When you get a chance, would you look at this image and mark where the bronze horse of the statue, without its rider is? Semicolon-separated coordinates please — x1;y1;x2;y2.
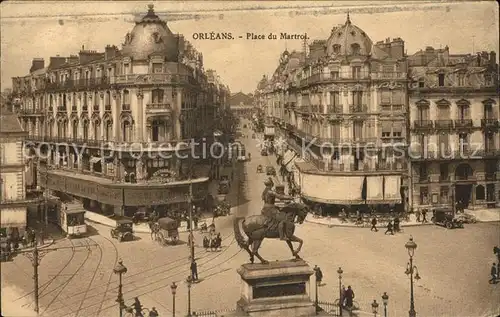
234;202;309;264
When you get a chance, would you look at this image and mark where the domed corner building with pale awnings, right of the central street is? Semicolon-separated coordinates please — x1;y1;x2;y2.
259;16;409;211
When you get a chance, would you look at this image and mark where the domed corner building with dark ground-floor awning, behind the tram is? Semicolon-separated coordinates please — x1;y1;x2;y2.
13;5;230;214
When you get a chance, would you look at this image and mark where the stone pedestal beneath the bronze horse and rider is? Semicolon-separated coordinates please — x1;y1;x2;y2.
237;261;315;317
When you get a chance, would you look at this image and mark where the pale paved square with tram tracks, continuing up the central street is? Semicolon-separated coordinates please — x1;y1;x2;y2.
2;121;500;317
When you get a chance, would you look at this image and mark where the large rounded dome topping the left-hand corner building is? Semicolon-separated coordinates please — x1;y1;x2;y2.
122;4;179;62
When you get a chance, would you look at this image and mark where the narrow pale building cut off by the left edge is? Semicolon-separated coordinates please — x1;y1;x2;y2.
0;110;30;234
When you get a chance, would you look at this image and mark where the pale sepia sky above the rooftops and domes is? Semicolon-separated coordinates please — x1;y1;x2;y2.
0;0;499;93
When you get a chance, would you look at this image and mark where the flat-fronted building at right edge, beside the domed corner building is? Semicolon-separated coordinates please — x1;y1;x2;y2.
409;47;500;208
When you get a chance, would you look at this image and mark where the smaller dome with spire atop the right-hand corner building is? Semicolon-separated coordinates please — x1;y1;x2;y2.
326;13;373;56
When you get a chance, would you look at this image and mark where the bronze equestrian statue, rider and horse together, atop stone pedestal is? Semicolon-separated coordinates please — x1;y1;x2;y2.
234;179;309;264
